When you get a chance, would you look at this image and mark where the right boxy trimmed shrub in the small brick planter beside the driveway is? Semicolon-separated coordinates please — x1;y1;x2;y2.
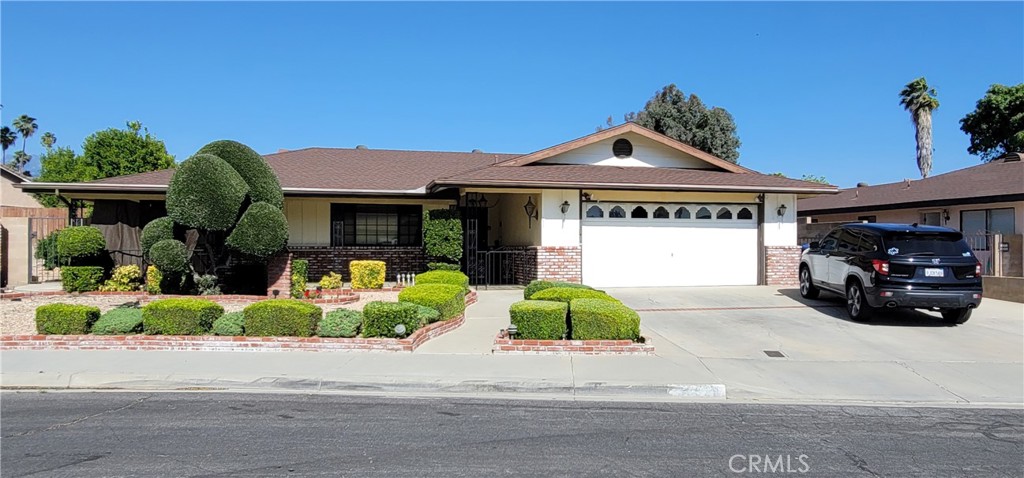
569;299;640;342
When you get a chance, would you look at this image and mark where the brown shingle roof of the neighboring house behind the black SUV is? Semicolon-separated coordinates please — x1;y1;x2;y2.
797;159;1024;216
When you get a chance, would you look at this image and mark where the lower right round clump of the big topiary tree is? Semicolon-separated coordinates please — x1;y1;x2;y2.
226;201;288;259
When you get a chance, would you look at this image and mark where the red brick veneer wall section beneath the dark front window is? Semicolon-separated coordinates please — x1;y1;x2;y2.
289;246;427;280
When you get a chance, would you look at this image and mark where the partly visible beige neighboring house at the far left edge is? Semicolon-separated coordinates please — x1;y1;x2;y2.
0;166;68;288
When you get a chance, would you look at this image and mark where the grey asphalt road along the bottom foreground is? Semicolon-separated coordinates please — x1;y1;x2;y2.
0;392;1024;477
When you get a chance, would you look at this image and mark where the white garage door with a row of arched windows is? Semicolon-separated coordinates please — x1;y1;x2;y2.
583;203;758;288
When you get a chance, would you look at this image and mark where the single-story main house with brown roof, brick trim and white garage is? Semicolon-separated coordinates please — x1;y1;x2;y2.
14;123;836;288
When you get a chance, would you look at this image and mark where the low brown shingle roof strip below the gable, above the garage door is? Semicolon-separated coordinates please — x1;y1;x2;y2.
435;165;836;192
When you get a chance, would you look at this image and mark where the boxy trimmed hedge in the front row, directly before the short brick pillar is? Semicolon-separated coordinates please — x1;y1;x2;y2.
244;299;324;337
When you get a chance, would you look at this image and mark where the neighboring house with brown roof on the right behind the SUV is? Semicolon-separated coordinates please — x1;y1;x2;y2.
797;153;1024;275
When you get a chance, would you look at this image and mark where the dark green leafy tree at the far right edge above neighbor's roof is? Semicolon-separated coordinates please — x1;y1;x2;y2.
961;83;1024;162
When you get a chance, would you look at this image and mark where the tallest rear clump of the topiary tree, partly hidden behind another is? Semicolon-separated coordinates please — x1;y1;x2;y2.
198;139;285;209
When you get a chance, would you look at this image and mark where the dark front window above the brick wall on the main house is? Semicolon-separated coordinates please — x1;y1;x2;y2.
331;204;423;247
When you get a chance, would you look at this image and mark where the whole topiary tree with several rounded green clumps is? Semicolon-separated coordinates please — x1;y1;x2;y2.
140;140;288;294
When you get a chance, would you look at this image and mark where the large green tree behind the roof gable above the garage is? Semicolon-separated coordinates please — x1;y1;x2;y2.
626;84;740;163
